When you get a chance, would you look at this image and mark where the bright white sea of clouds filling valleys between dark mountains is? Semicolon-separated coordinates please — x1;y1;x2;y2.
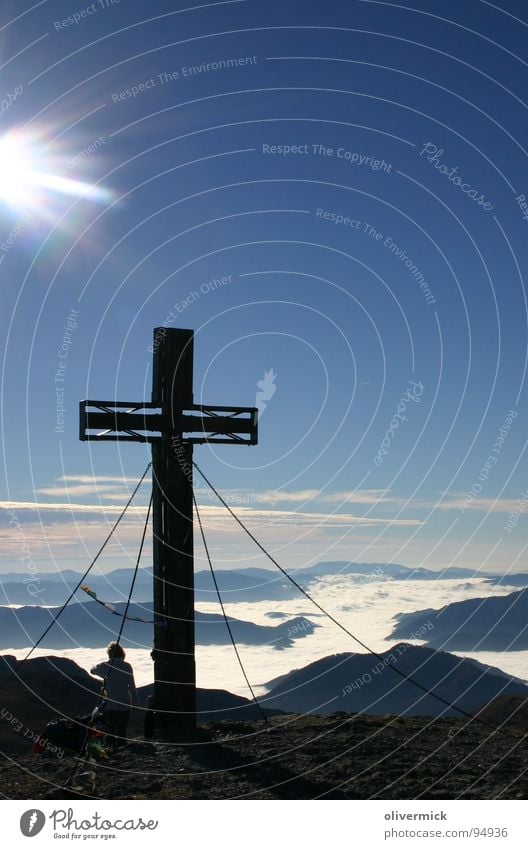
2;575;528;697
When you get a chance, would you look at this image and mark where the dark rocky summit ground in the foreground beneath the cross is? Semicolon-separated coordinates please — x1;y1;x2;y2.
0;714;528;799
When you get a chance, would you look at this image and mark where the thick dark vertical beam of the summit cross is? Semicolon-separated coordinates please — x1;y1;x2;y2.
152;328;196;734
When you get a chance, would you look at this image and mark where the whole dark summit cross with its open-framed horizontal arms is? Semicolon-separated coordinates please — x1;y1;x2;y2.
80;327;258;734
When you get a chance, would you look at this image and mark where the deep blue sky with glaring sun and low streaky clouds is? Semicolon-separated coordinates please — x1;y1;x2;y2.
0;0;528;572
